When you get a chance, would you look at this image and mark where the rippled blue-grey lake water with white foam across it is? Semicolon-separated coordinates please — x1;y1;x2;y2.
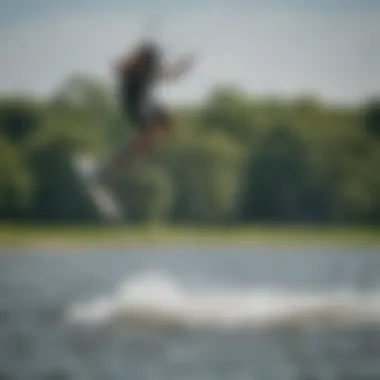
0;246;380;380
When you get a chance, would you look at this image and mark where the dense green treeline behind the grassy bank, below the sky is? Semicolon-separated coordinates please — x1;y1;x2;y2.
0;76;380;225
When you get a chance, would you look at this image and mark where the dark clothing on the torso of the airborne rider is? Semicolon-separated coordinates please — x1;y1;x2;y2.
121;45;167;129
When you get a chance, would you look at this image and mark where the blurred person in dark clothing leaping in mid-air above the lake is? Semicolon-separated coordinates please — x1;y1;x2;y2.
87;42;194;217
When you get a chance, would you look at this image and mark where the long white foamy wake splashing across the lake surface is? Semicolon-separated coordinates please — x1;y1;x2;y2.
67;274;380;329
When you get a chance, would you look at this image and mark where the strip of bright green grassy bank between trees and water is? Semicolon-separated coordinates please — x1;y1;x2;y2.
0;225;380;248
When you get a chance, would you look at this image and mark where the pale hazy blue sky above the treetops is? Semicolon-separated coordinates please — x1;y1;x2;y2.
0;0;380;102
